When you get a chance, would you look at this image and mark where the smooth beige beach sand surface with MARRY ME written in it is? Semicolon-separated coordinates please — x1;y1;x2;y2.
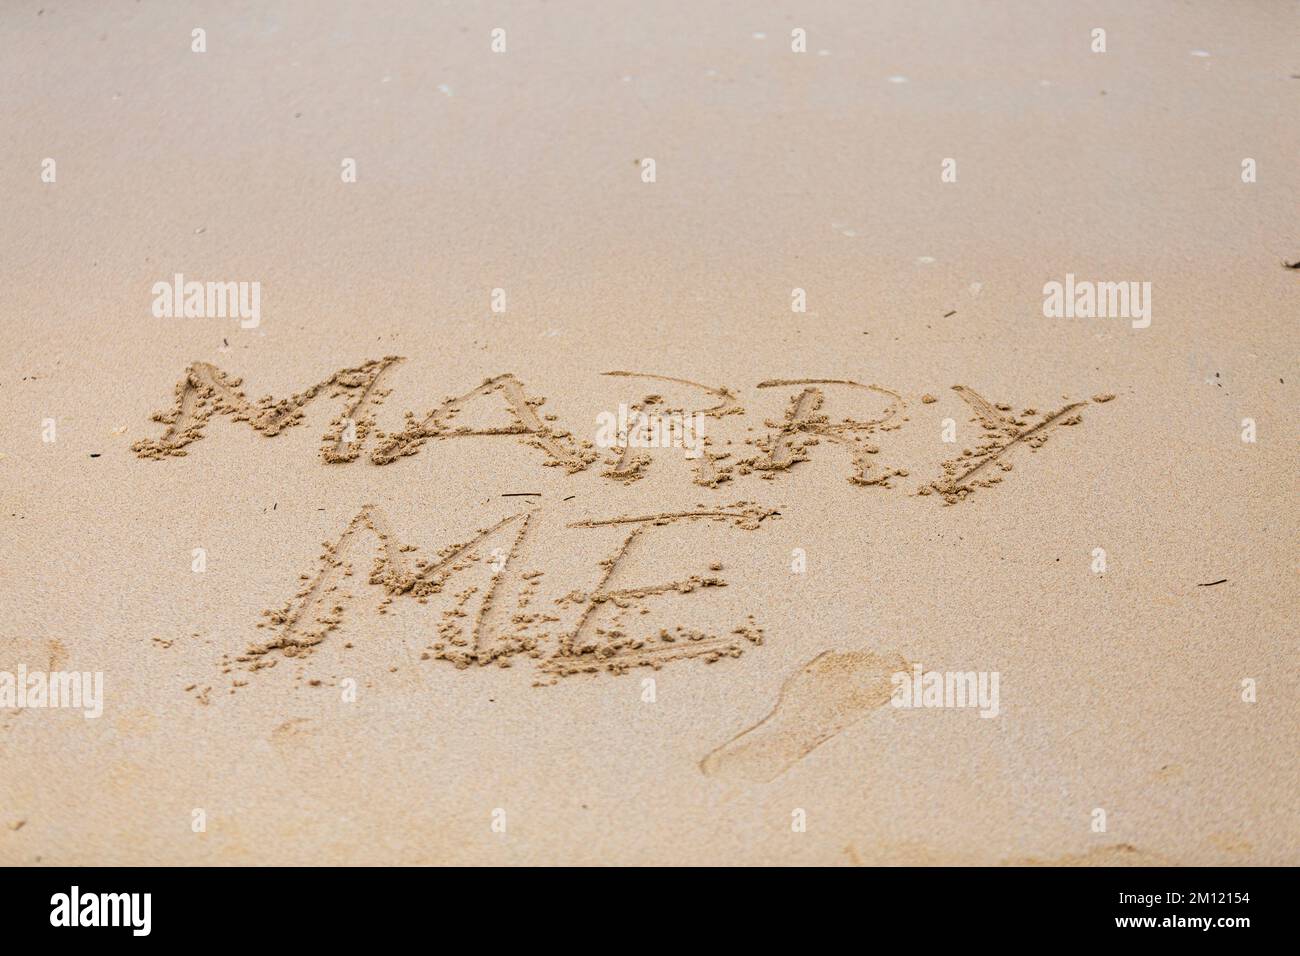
0;0;1300;865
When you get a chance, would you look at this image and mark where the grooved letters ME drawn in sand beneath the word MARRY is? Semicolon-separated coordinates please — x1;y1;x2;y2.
231;502;777;676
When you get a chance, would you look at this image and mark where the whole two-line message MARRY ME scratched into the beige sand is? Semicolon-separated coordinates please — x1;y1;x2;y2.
133;355;1113;700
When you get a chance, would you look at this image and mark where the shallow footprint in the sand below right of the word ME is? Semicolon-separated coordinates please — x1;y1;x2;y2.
699;650;907;783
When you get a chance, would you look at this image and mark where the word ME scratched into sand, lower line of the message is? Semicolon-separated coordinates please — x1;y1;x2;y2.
224;502;779;684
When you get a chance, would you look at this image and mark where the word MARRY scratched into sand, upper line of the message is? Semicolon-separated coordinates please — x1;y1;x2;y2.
131;355;1112;505
